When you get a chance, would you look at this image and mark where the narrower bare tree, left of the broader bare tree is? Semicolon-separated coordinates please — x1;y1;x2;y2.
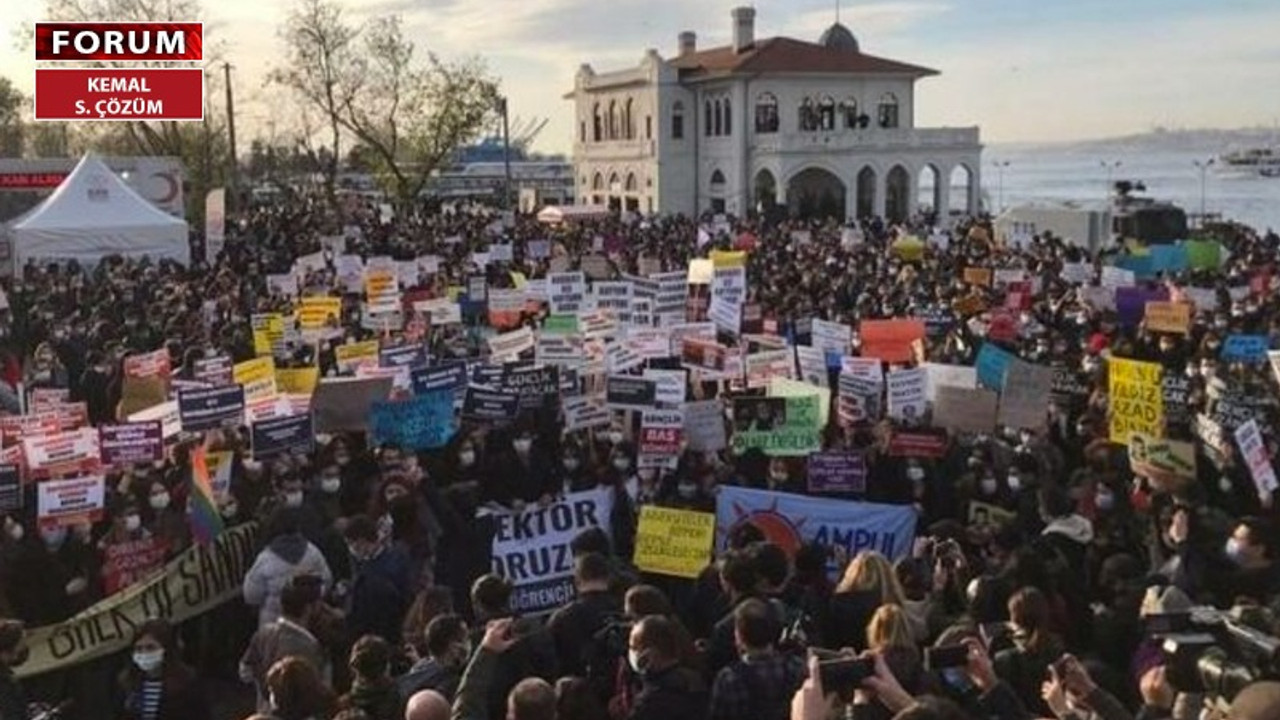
269;0;360;214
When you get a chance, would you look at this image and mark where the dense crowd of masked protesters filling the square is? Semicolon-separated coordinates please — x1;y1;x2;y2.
0;188;1280;720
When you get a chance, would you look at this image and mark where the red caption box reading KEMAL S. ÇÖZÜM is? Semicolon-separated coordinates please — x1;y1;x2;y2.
36;68;205;122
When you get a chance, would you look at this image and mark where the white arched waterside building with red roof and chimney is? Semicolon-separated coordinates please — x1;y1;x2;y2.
566;8;982;219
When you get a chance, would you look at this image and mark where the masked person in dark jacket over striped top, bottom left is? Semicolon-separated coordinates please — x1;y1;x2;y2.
120;619;212;720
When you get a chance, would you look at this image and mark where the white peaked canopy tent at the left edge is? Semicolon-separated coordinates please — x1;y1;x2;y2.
9;152;191;272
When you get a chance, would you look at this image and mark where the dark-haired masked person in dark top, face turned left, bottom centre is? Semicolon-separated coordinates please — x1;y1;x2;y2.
627;615;707;720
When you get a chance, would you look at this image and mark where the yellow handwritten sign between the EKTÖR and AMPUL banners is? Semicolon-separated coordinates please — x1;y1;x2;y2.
635;505;716;578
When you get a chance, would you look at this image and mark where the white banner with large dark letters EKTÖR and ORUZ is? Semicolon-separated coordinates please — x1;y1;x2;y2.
493;488;613;615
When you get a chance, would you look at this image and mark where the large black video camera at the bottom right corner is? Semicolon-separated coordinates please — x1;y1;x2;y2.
1148;607;1280;703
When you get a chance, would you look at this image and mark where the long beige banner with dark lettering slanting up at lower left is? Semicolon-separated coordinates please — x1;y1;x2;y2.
14;523;259;678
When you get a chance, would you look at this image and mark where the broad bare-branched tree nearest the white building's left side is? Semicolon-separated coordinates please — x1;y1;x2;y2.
338;15;498;205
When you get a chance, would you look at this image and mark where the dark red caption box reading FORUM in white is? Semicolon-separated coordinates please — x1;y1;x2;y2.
36;22;205;61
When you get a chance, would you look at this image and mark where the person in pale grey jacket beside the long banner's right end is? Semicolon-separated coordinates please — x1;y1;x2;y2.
242;509;333;628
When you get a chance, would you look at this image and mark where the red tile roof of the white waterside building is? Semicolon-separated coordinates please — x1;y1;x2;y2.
671;37;938;78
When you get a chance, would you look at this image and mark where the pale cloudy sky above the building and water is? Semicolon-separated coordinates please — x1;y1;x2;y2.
0;0;1280;151
